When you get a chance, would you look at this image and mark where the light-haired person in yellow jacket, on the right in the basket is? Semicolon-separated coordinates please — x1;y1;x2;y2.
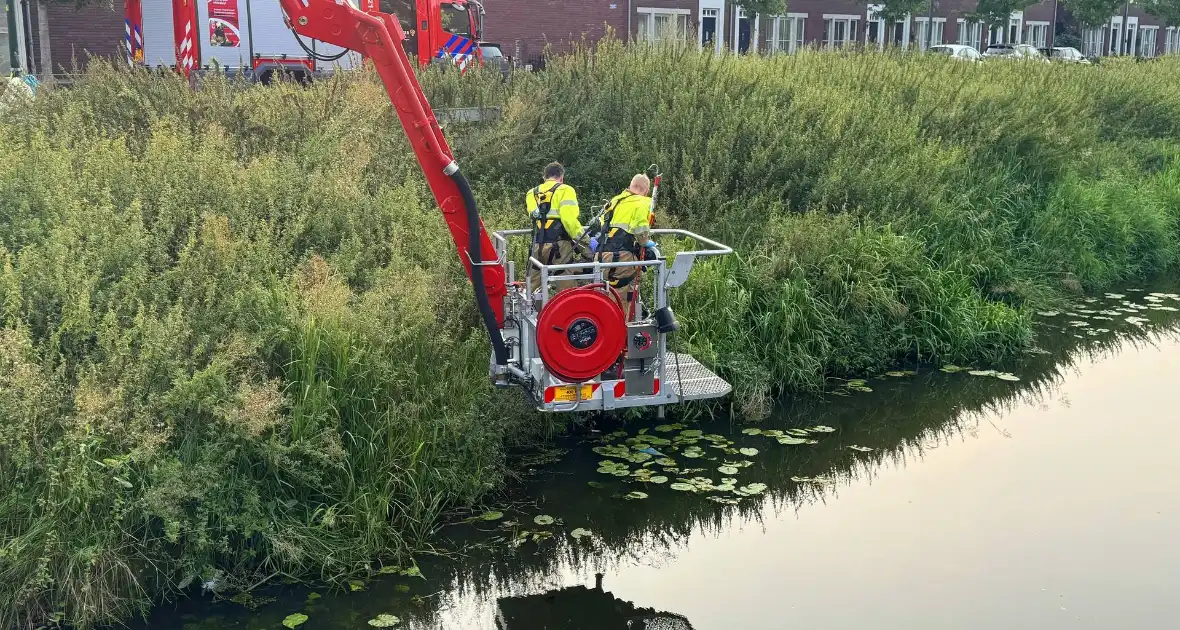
595;175;655;321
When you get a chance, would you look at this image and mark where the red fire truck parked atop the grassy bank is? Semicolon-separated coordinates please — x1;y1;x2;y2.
124;0;484;83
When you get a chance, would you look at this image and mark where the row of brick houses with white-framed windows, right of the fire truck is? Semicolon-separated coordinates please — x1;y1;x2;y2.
484;0;1180;64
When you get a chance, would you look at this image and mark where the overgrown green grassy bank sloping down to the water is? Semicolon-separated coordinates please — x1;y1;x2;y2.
0;44;1180;628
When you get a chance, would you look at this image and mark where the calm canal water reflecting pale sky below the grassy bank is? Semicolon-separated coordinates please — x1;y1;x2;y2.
150;289;1180;630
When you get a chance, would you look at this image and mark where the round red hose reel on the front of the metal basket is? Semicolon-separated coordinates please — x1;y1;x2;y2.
537;283;627;382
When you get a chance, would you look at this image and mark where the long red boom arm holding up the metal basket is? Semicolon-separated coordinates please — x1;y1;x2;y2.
280;0;507;335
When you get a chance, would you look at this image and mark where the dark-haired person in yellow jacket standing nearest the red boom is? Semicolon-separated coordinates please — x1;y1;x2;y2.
525;162;585;296
